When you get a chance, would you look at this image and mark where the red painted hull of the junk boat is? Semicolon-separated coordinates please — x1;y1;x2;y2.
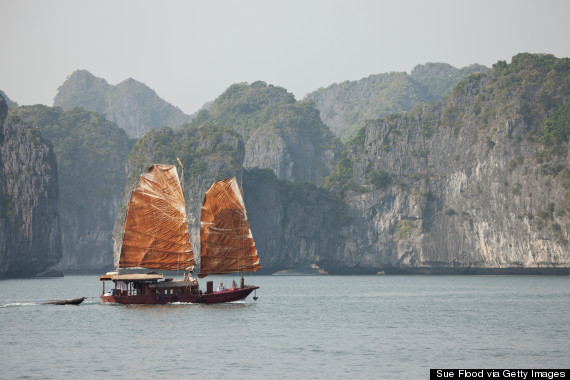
101;286;259;305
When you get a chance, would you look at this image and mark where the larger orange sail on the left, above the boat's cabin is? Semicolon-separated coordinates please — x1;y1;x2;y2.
119;165;194;270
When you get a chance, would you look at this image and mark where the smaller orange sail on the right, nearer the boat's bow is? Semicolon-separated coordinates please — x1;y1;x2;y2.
199;178;261;277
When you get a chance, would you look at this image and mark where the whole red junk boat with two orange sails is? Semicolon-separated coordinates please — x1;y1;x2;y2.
99;165;261;305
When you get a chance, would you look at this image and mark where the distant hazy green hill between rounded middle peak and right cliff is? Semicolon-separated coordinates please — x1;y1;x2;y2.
304;63;488;142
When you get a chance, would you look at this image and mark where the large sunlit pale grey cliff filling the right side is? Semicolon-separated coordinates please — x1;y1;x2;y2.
320;54;570;270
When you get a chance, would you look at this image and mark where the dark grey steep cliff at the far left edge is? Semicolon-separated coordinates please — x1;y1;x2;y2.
0;96;61;277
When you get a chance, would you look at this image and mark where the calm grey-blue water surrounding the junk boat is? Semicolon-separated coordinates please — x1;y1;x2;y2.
0;276;570;379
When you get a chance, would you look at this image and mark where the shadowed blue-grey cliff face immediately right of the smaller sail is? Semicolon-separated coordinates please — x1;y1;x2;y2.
243;169;348;274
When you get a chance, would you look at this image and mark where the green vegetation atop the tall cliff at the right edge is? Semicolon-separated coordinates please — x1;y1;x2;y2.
446;53;570;162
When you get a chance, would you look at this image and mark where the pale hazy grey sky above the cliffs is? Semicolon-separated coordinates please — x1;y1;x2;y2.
0;0;570;114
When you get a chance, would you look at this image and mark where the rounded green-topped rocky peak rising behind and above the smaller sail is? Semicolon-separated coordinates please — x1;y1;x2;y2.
193;82;341;184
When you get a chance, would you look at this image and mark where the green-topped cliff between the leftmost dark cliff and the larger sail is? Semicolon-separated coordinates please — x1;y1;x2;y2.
10;105;132;271
